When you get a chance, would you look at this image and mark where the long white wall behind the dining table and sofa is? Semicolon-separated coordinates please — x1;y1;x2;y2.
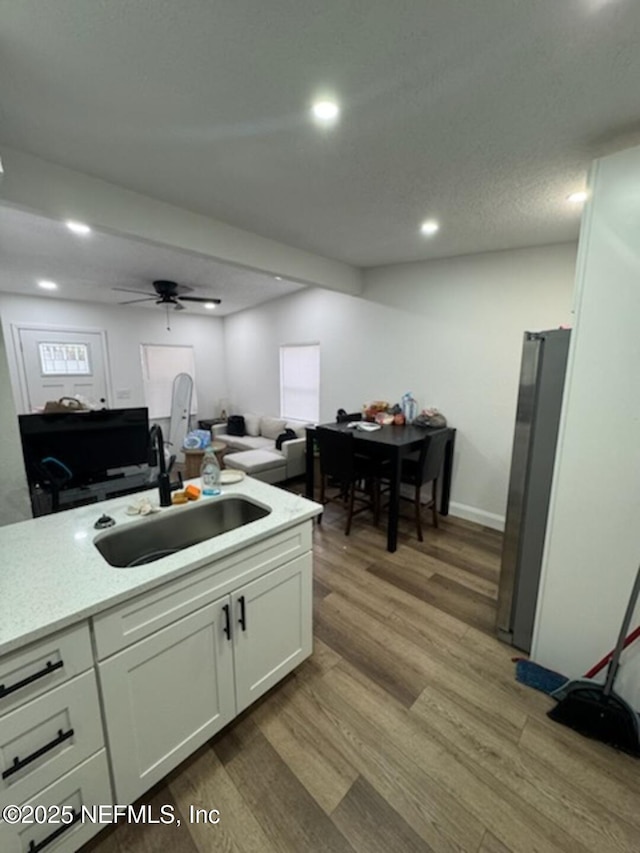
225;244;576;527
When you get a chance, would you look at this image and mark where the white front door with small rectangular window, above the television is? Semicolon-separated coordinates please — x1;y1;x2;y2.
16;326;109;412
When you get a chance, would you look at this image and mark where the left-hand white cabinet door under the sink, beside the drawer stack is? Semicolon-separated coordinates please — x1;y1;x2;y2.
98;597;235;803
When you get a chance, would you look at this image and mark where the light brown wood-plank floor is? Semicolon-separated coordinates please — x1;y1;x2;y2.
86;500;640;853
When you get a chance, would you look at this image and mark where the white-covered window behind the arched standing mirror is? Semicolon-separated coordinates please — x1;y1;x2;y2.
140;344;198;419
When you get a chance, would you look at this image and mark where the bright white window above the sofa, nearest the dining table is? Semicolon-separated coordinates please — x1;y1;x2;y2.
280;344;320;423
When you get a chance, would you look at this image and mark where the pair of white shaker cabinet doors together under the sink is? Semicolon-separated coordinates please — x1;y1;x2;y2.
98;552;312;803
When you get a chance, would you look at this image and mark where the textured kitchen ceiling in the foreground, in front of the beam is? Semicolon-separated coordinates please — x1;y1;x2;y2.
0;0;640;266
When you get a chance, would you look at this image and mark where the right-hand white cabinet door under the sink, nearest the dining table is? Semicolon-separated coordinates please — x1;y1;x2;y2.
231;553;312;713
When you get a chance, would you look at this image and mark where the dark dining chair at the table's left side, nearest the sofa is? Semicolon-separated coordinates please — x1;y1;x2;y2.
314;427;379;536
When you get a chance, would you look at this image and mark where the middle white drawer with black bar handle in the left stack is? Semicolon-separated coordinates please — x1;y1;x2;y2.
0;670;103;806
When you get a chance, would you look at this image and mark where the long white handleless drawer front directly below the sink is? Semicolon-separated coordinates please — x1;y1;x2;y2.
93;522;311;660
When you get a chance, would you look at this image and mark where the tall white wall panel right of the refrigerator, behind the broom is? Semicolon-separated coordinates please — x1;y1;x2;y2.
532;148;640;708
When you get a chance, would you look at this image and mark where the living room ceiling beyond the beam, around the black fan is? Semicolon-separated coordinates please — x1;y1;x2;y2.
0;206;303;317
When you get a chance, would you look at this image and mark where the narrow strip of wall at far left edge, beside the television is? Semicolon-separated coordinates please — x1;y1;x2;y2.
0;328;31;525
